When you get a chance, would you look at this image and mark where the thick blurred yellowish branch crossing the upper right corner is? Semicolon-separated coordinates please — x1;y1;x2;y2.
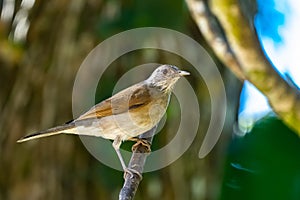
187;0;300;136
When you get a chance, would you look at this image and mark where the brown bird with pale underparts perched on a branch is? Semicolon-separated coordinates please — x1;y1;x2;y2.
17;64;190;177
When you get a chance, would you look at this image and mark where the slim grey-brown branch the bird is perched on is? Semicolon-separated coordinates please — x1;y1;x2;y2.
119;126;157;200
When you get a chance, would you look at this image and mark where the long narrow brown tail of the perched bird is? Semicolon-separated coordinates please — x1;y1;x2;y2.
17;123;76;143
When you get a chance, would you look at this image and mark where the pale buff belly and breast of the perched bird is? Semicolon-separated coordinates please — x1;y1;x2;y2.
74;98;165;140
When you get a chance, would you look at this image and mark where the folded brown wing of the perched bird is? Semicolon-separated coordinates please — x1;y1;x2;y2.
75;82;151;121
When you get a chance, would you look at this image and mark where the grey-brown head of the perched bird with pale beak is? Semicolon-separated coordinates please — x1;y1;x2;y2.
146;65;190;91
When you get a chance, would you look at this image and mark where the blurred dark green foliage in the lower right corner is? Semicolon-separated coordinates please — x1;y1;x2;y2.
221;117;300;200
